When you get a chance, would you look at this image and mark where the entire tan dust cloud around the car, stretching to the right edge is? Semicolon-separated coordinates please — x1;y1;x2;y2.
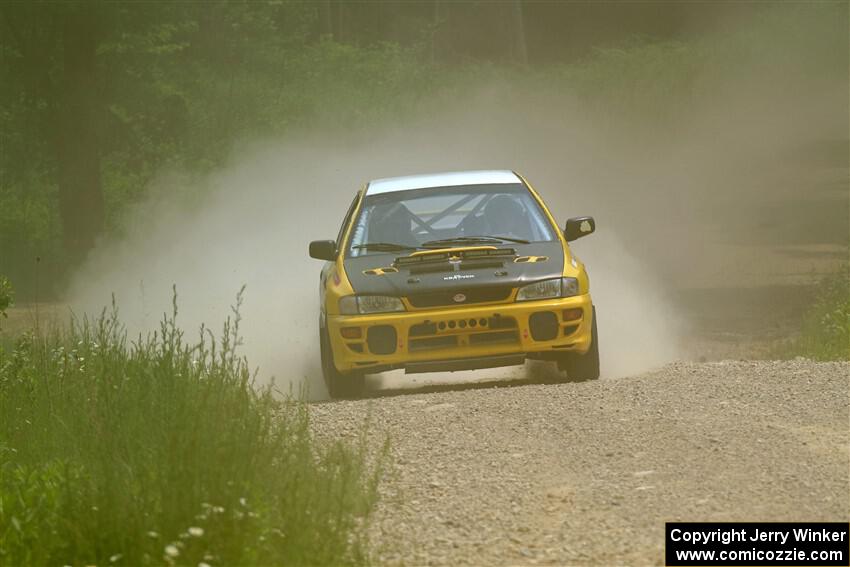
69;11;847;398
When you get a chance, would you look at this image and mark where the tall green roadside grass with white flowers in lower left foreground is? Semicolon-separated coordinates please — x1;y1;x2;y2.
0;290;386;565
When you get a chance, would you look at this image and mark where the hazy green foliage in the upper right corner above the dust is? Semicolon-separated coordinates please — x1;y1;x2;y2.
531;3;848;135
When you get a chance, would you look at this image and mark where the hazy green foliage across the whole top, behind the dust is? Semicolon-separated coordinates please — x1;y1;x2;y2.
0;2;847;298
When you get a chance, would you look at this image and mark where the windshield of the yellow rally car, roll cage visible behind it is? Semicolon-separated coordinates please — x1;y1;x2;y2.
347;183;555;256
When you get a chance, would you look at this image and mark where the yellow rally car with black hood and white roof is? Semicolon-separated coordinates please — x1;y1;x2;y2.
310;171;599;398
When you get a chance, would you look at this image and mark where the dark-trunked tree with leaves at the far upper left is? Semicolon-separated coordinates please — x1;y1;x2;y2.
2;2;104;262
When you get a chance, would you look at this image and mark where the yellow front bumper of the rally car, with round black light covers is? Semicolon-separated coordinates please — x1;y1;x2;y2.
327;294;593;372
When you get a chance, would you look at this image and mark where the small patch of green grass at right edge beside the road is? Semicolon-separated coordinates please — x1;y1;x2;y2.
788;265;850;360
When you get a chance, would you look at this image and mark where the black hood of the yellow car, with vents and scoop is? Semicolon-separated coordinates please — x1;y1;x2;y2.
345;241;564;300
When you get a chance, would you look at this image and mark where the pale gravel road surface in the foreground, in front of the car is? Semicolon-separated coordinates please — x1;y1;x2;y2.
311;360;850;565
